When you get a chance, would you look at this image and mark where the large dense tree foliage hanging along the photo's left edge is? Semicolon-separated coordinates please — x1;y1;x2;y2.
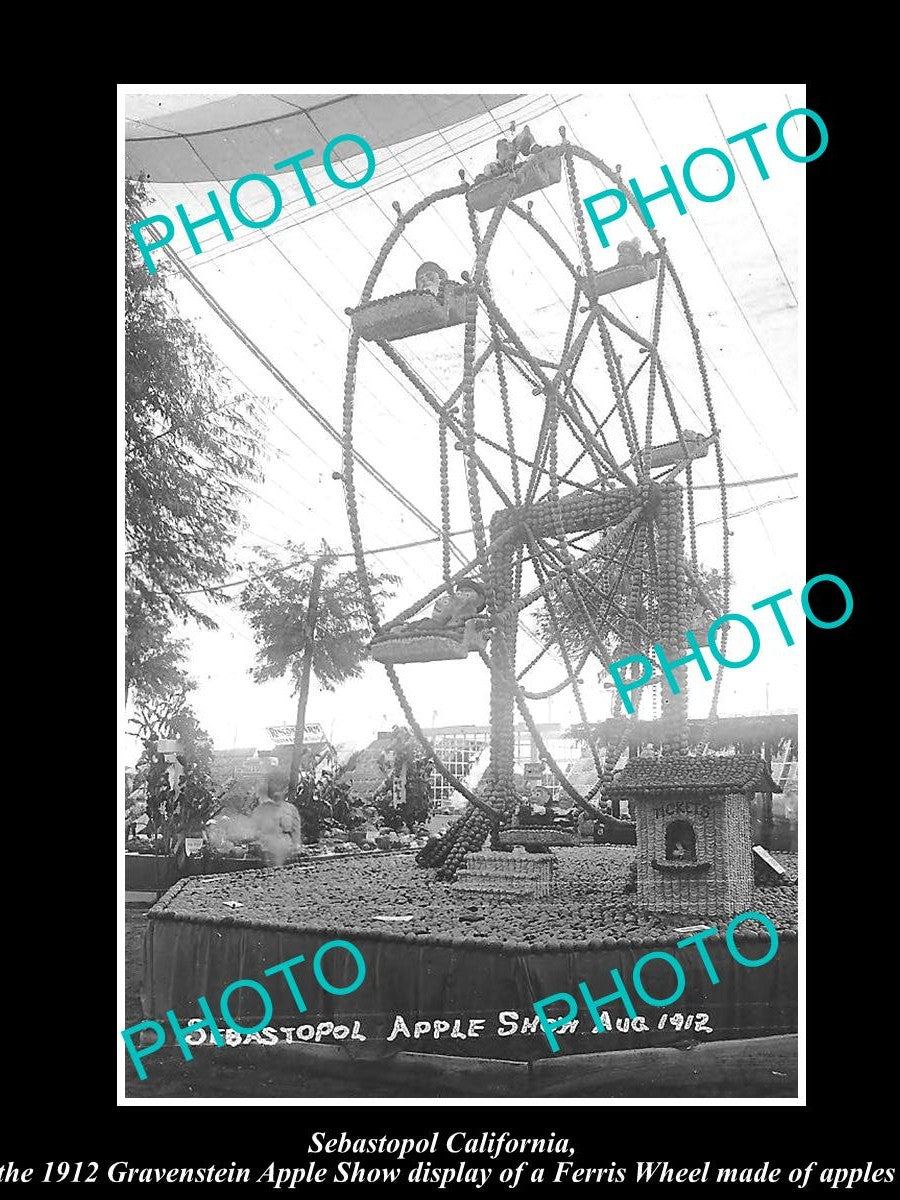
125;182;262;688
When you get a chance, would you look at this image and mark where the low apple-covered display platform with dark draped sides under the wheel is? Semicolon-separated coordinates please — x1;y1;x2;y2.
142;846;797;1061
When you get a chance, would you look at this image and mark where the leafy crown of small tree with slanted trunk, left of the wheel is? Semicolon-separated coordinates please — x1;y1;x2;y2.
240;542;398;691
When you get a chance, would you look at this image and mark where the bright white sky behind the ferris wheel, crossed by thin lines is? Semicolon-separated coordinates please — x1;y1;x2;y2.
126;85;815;763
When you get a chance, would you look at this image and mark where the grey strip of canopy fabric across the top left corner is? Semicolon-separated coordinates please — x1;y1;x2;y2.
125;94;516;184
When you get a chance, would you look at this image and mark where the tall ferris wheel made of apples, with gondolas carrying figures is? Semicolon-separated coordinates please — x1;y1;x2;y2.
342;126;728;844
